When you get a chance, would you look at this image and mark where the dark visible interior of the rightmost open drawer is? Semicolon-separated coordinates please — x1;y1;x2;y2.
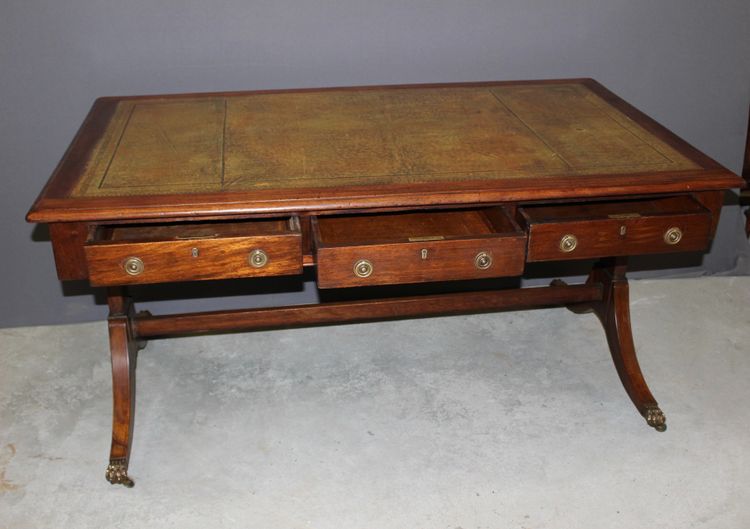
519;195;708;224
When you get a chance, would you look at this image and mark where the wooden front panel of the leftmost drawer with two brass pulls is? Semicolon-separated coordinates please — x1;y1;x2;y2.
85;221;302;286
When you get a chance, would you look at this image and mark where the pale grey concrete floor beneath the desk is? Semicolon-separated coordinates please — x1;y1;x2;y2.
0;277;750;529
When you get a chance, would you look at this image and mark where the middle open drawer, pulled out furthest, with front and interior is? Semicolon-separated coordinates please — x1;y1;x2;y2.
312;207;526;288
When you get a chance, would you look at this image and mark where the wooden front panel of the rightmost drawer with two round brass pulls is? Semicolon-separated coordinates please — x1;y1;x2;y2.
528;212;711;262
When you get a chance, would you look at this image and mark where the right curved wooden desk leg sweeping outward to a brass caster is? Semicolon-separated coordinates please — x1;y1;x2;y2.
556;258;667;432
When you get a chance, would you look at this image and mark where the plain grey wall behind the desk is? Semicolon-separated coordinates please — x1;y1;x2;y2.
0;0;750;325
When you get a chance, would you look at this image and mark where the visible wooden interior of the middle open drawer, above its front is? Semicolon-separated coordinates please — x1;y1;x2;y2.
314;207;521;246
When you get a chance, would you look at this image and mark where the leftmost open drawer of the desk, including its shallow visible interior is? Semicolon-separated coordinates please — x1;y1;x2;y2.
84;217;302;285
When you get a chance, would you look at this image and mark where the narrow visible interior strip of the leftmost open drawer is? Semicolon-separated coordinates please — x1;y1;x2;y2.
94;217;300;243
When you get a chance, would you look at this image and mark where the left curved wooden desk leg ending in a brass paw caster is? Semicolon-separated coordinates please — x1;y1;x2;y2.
105;289;142;487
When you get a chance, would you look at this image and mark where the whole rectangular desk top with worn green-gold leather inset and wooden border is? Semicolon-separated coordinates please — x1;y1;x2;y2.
28;79;737;222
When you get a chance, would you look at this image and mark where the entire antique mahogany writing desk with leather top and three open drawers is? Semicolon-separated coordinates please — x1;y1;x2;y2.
28;79;742;486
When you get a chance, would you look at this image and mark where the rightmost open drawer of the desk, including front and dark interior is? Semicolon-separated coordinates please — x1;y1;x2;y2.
518;195;711;262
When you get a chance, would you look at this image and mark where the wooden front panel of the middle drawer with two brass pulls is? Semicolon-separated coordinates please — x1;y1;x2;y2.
317;237;525;288
